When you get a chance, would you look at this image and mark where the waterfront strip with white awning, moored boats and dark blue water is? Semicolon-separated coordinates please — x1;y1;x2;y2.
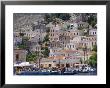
14;64;97;75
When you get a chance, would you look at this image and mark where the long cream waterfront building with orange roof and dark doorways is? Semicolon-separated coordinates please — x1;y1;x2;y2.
40;56;80;68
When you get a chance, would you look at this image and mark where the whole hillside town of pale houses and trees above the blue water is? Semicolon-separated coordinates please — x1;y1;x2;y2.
13;13;97;75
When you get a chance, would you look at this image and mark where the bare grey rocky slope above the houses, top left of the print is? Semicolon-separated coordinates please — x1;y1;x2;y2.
13;13;44;31
